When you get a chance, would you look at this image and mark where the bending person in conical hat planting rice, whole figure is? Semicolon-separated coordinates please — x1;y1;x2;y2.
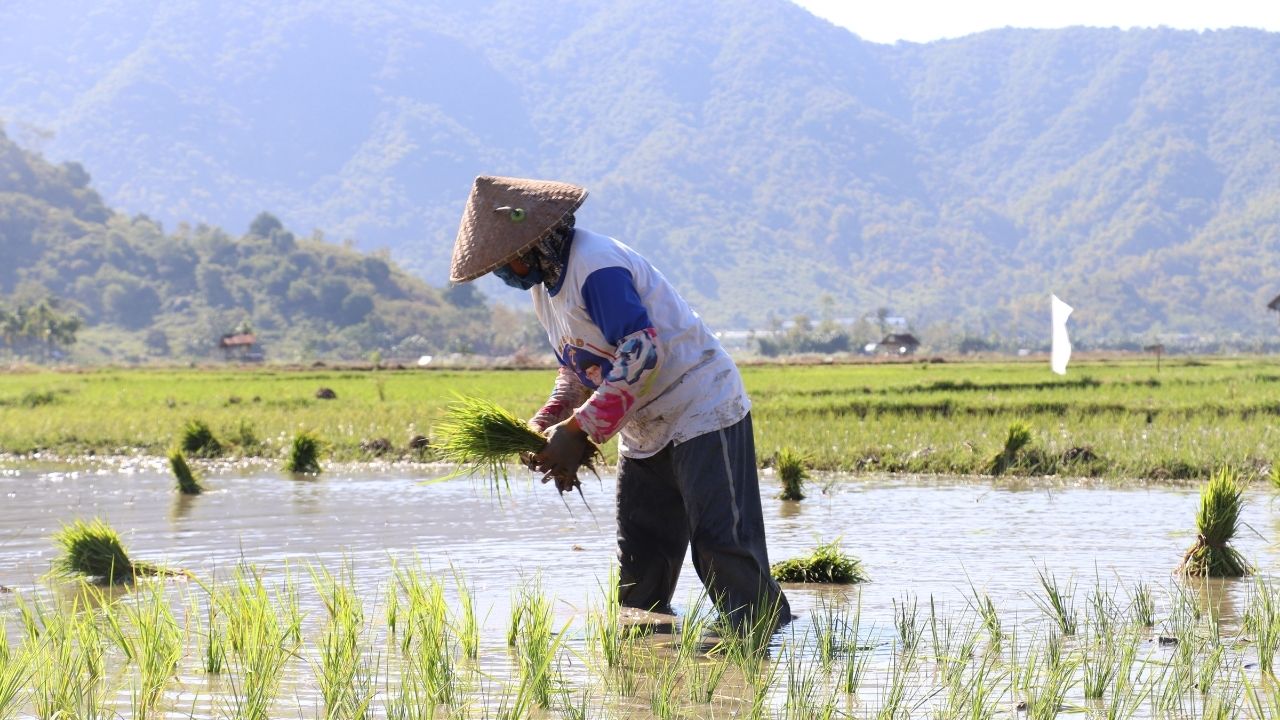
449;177;791;630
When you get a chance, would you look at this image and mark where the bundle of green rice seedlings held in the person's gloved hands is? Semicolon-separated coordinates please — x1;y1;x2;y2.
435;397;599;492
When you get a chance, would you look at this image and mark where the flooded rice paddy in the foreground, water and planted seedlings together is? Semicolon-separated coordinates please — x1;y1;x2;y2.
0;464;1280;720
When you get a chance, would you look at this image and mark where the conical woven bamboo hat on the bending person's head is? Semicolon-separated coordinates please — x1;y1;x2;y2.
449;176;586;283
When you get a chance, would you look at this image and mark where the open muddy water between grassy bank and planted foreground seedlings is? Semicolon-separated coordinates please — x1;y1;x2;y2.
0;464;1280;716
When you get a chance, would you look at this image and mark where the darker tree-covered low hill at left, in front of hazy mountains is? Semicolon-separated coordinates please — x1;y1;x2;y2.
0;128;530;360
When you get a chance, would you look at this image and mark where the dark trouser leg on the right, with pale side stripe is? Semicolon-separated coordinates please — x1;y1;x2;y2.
671;414;791;630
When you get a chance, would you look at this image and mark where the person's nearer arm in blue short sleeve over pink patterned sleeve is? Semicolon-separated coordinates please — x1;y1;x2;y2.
572;268;663;445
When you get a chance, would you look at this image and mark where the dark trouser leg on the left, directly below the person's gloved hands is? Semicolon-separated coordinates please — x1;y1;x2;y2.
618;448;689;612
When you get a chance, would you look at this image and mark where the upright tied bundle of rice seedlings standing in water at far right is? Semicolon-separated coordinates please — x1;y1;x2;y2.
1178;468;1252;578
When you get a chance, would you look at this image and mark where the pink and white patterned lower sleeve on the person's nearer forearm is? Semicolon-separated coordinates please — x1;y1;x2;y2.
573;328;663;445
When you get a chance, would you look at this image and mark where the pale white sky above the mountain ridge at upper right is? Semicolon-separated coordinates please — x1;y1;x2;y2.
794;0;1280;44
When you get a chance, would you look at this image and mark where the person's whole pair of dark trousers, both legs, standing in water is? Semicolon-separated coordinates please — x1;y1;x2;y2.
618;414;791;629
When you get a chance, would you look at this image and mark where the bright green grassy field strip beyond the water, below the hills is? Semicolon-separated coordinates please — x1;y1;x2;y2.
0;359;1280;479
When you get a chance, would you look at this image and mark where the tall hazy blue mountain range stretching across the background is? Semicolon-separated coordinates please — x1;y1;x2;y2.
0;0;1280;343
